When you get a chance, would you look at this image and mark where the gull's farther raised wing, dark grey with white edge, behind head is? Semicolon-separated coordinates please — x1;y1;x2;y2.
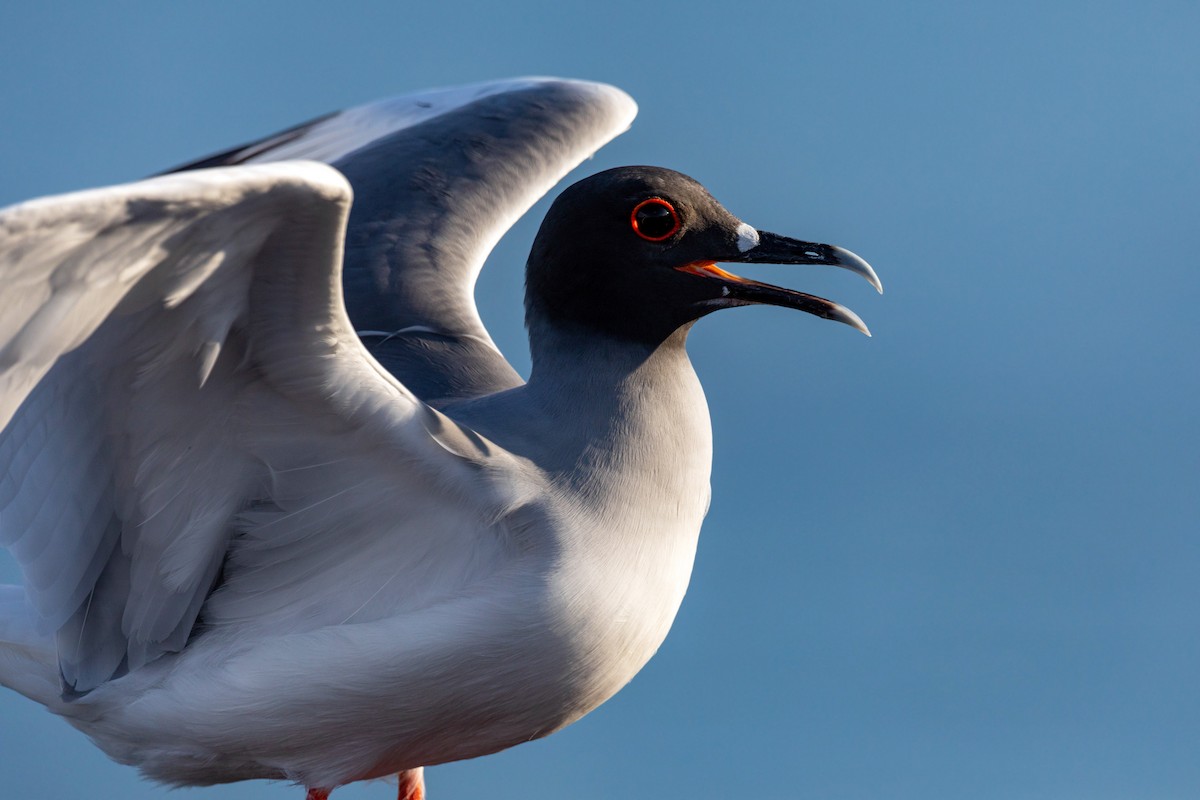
171;79;637;403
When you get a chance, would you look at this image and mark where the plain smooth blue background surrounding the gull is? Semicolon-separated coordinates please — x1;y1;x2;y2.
0;0;1200;800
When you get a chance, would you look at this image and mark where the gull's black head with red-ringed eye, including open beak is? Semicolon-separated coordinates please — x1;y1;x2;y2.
526;167;882;344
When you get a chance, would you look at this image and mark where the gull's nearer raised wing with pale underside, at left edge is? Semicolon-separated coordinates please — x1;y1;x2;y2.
0;162;518;692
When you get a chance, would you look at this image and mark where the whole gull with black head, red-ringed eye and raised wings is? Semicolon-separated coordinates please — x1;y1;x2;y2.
0;78;882;800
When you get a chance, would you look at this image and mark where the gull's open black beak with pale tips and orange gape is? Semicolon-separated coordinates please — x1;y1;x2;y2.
676;225;883;336
